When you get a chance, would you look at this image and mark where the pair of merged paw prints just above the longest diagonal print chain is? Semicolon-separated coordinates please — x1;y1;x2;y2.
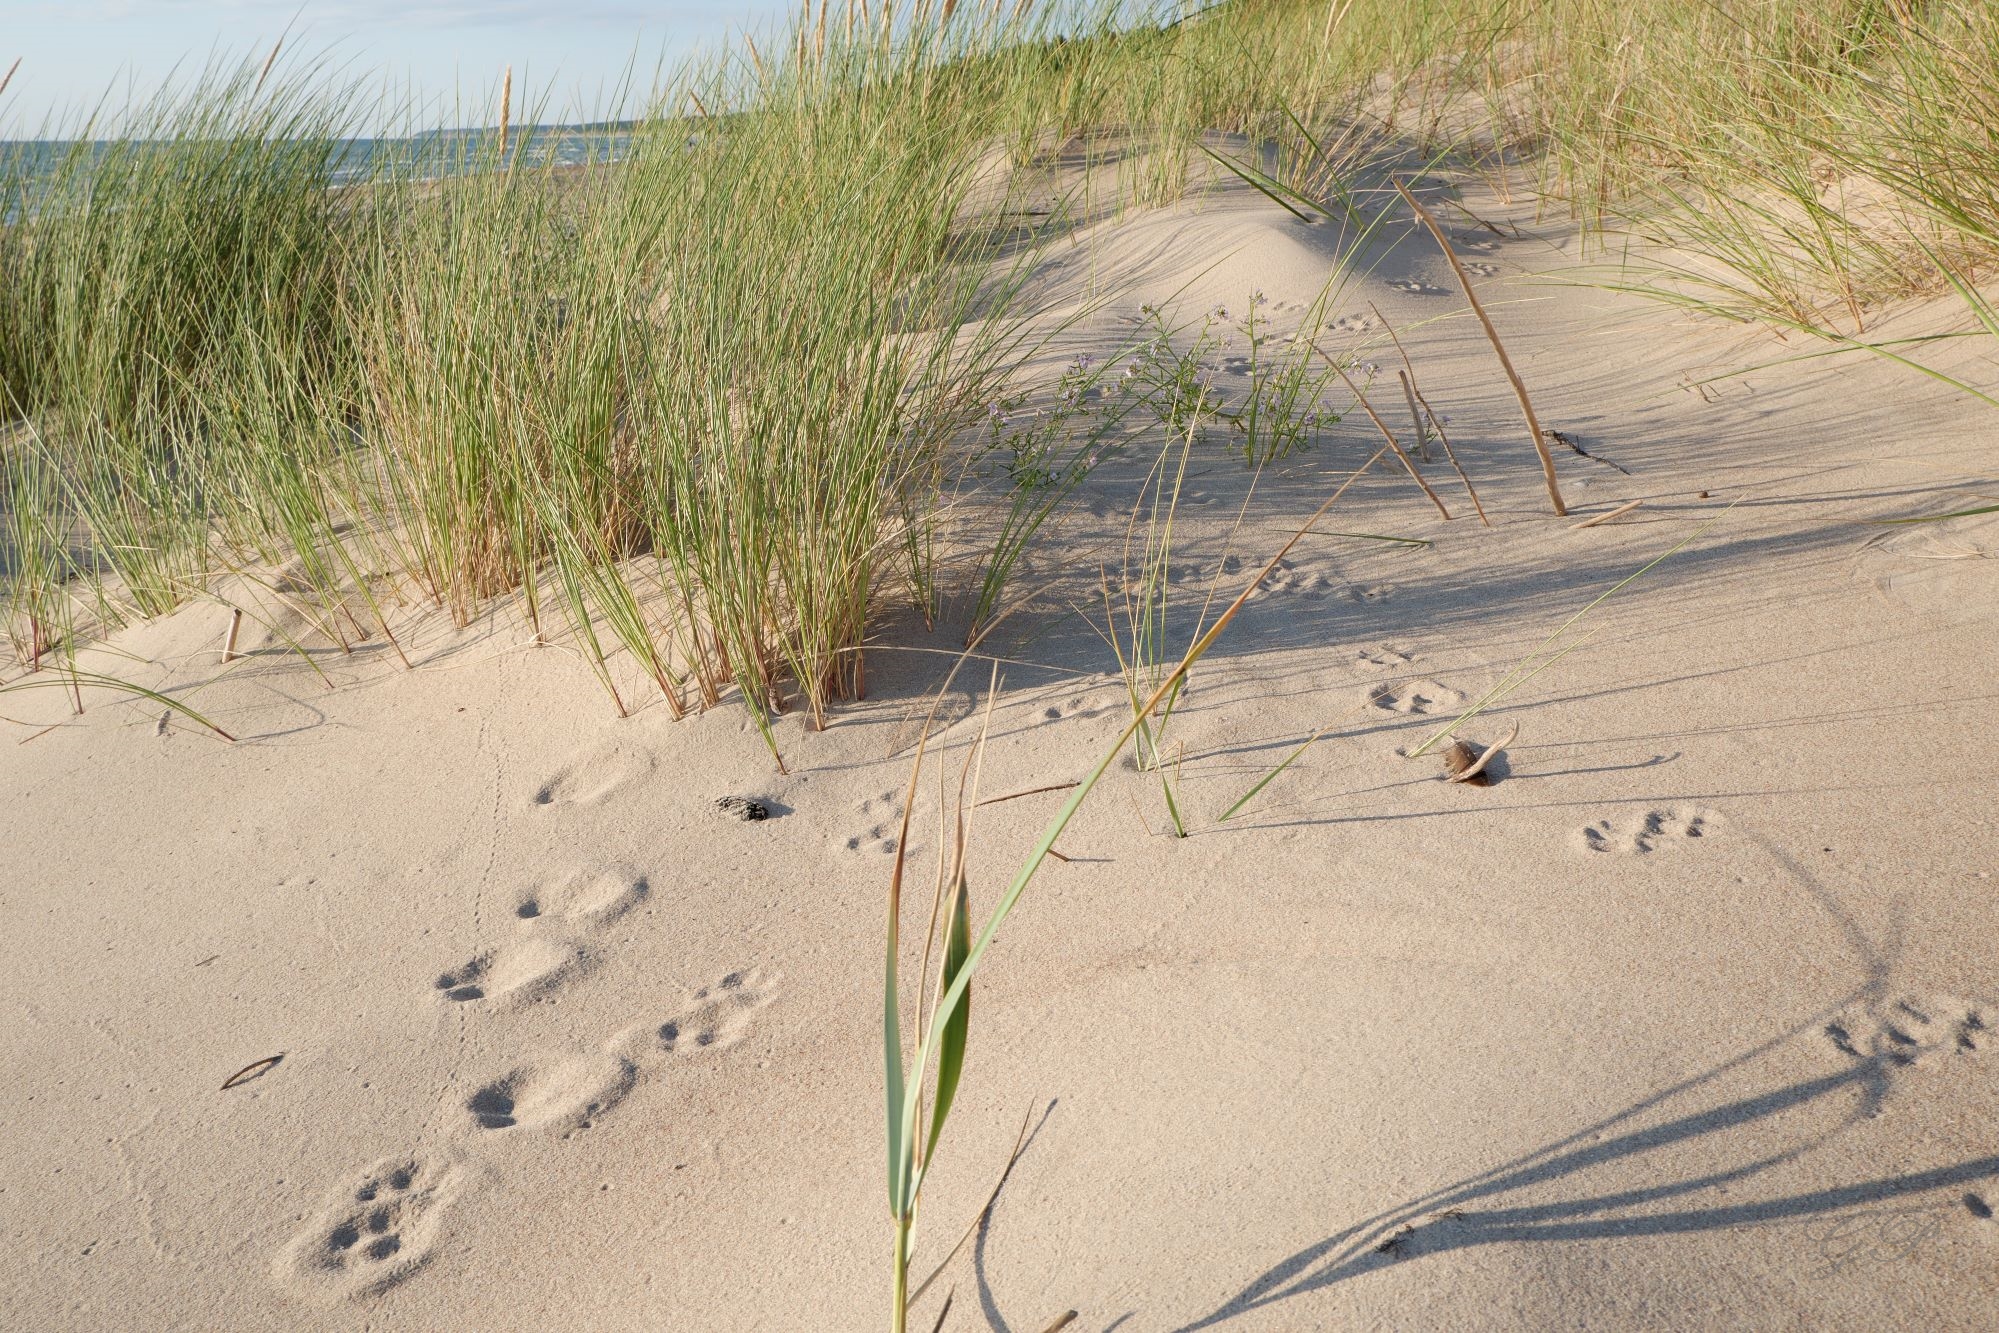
432;869;648;1005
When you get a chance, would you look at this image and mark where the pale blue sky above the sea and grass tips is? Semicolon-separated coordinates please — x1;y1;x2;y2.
0;0;792;129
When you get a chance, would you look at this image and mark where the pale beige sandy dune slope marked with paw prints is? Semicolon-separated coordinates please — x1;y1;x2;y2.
0;171;1999;1333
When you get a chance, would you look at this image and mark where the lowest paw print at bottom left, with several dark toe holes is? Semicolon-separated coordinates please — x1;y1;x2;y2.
278;1155;458;1299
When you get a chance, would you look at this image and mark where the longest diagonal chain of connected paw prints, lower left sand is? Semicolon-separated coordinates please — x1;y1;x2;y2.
276;969;772;1303
